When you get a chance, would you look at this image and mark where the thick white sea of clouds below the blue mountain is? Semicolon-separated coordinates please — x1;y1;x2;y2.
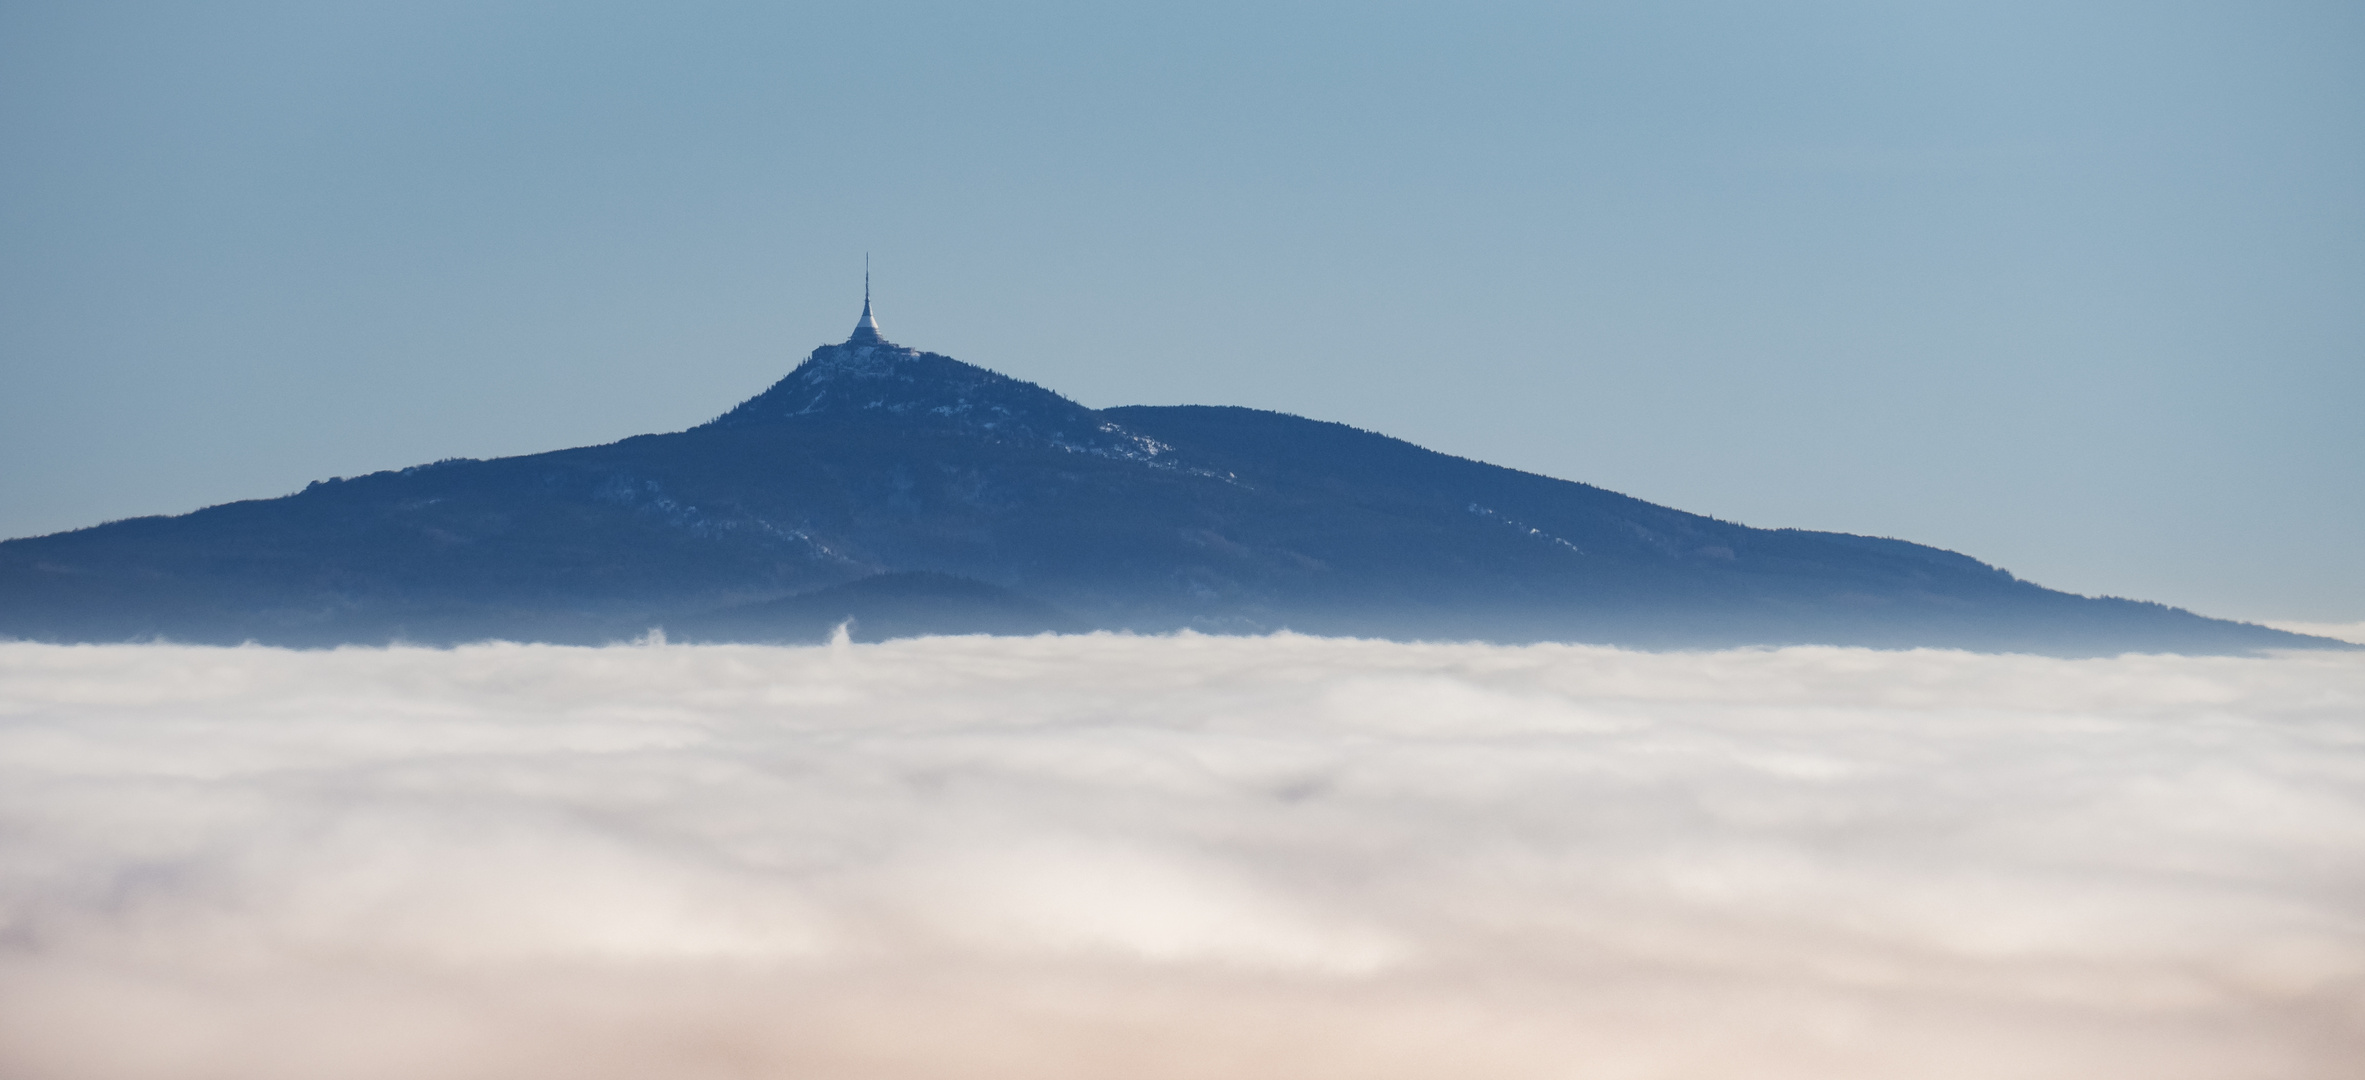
0;636;2365;1080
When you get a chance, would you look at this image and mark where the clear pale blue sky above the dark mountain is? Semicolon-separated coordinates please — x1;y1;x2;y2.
0;0;2365;619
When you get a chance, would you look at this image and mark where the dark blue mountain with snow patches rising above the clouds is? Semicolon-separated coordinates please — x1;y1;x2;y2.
0;298;2344;655
